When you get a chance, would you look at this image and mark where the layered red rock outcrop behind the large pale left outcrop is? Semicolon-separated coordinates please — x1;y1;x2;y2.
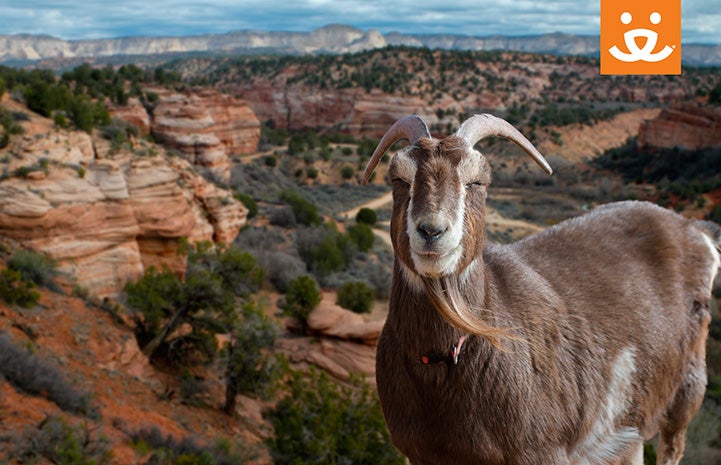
150;89;260;182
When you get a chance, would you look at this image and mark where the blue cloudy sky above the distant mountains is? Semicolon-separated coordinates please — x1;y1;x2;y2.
0;0;721;44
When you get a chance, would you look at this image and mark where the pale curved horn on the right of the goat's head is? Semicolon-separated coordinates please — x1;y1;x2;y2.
456;113;553;174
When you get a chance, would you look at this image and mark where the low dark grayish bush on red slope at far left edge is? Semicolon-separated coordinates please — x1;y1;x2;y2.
0;331;100;418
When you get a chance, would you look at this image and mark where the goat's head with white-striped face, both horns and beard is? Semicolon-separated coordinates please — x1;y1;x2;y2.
361;114;551;340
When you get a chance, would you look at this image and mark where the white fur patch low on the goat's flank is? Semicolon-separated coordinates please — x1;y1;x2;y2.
571;347;642;465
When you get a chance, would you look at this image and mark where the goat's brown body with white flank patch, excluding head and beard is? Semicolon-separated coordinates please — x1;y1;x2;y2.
376;202;719;465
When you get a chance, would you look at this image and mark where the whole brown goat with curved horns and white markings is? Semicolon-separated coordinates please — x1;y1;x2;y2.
361;115;721;465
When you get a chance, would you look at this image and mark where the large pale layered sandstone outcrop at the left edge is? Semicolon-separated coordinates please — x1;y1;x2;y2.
0;102;247;297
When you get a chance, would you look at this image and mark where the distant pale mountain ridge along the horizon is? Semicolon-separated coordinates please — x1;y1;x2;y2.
0;24;721;66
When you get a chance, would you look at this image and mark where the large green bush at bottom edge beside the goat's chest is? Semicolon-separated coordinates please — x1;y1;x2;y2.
268;369;405;465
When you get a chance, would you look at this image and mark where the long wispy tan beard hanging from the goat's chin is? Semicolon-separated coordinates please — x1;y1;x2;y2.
421;275;516;349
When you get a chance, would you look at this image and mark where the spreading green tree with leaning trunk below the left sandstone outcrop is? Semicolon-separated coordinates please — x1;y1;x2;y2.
125;242;263;362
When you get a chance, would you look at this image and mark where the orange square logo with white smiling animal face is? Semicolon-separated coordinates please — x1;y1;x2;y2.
601;0;681;74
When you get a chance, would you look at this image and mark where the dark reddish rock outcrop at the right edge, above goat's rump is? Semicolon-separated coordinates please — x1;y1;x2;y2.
638;106;721;150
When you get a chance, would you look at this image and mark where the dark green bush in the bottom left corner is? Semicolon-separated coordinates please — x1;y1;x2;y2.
10;416;113;465
